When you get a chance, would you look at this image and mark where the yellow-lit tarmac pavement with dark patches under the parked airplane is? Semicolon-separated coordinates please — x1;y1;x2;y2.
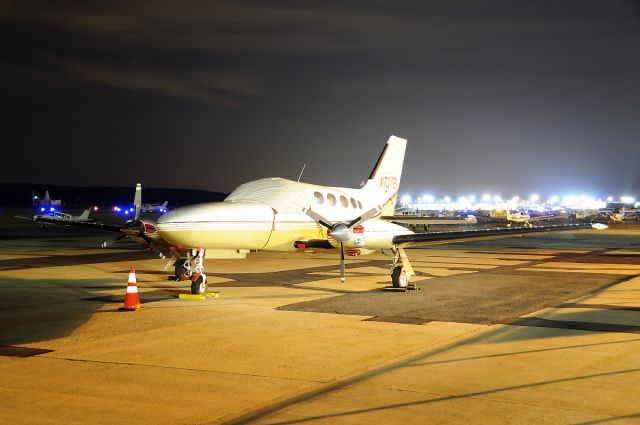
0;226;640;424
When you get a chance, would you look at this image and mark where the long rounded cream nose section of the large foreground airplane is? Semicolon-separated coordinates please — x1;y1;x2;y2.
157;202;274;250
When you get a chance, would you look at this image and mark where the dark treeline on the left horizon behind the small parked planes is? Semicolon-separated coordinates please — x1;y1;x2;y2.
0;183;227;208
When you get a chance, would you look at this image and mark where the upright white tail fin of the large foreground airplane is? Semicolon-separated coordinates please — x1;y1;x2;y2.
363;136;407;215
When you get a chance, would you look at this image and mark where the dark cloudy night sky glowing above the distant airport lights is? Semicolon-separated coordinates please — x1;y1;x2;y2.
0;0;640;196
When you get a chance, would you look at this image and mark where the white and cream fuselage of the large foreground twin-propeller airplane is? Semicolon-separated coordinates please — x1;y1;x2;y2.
157;178;412;253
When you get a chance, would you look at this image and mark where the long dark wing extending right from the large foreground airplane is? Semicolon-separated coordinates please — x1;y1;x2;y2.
393;223;592;247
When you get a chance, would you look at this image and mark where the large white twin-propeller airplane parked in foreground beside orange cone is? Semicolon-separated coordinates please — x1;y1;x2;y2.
26;136;604;294
